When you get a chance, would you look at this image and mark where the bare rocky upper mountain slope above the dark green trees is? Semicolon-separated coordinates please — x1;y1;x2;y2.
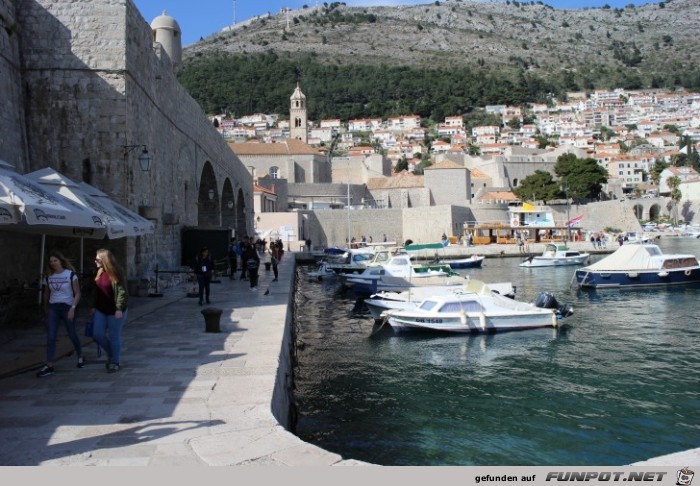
183;0;700;117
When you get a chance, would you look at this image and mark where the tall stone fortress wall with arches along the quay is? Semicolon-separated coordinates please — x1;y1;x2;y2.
0;0;253;281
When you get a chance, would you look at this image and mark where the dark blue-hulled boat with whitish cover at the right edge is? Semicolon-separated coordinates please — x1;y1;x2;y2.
572;244;700;289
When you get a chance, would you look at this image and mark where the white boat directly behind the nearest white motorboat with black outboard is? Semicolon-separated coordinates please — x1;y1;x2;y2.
364;280;516;320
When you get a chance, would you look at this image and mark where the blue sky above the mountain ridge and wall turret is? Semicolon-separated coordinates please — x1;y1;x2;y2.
133;0;659;46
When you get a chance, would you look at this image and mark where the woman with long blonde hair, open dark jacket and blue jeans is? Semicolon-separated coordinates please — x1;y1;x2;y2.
93;248;128;373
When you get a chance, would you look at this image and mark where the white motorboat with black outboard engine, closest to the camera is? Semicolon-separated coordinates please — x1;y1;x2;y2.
373;284;573;334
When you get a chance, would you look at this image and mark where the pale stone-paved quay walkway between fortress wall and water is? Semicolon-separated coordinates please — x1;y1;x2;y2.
0;247;700;466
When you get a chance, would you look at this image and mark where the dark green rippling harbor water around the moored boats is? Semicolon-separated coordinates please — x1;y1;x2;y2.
294;238;700;466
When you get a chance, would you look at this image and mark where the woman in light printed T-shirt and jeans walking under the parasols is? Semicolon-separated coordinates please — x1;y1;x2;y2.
36;251;85;378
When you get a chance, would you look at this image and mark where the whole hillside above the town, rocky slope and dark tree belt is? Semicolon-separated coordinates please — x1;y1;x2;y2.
180;0;700;117
